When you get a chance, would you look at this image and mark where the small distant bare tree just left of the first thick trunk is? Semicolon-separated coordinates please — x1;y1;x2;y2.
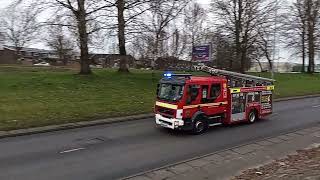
46;26;74;65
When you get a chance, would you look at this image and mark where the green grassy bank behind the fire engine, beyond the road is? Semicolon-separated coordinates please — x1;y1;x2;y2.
0;66;320;130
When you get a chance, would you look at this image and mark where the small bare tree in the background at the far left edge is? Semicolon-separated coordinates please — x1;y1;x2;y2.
0;5;41;58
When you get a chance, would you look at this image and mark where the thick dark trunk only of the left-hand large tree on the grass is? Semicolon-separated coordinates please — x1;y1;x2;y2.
77;0;92;75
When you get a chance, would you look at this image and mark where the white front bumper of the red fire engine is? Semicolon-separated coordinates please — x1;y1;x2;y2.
155;114;190;130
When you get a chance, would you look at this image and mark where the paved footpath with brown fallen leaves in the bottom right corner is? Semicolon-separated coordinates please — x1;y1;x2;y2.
123;124;320;180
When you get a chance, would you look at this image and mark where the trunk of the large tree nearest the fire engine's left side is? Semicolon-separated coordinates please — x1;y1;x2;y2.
117;0;129;72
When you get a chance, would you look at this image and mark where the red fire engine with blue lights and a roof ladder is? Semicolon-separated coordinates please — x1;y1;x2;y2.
154;66;275;134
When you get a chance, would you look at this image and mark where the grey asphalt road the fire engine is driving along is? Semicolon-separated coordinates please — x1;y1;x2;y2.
0;98;320;180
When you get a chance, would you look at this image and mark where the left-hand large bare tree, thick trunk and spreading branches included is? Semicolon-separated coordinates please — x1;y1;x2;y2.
25;0;115;74
